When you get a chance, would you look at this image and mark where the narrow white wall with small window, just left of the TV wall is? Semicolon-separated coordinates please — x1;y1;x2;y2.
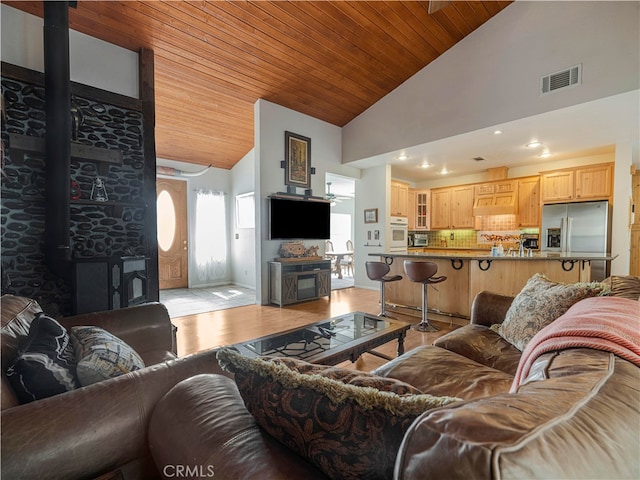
229;149;259;288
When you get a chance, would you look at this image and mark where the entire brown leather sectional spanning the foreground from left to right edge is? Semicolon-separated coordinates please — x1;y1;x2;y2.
0;278;640;480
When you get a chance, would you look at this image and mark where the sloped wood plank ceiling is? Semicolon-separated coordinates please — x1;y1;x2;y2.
3;0;511;169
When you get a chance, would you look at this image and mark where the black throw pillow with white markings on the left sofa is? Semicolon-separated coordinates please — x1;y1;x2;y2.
7;313;78;403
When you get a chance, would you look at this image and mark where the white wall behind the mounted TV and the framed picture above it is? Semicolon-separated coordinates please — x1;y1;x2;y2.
254;100;360;304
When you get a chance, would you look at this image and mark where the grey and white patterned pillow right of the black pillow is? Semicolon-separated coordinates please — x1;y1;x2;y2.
71;327;144;387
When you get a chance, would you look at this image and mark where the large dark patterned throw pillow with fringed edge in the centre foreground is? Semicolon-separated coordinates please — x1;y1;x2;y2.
218;349;459;479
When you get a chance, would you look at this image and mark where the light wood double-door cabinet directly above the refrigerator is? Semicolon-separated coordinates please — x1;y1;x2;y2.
540;163;613;203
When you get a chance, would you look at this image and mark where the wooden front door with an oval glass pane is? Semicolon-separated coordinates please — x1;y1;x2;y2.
156;178;189;290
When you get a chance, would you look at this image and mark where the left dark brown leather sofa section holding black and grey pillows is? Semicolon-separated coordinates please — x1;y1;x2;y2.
0;295;230;480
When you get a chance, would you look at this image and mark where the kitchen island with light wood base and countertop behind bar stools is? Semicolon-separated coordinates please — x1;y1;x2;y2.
369;250;617;319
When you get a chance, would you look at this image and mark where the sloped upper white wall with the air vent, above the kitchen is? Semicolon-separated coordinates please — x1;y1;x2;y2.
343;1;640;163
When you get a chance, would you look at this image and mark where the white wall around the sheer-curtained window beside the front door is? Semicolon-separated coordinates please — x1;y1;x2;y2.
157;158;234;288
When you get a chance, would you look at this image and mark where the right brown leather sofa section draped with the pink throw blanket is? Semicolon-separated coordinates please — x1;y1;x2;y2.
149;292;640;480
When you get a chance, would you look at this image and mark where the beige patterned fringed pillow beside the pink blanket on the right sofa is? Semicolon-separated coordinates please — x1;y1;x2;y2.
491;273;609;351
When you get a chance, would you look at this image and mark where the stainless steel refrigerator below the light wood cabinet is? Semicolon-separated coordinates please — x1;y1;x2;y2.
541;201;611;280
